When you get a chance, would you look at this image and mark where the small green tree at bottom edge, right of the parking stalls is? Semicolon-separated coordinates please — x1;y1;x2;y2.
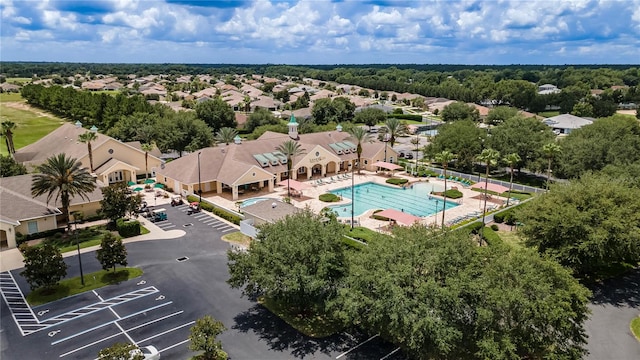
189;315;228;360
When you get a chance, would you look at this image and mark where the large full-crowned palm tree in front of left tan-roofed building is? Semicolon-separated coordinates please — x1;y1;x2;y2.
31;154;96;230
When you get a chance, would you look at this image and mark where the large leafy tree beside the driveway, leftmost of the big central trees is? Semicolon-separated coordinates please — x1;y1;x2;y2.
228;209;346;315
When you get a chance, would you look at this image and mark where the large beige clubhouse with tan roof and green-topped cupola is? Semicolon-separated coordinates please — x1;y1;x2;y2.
154;116;397;200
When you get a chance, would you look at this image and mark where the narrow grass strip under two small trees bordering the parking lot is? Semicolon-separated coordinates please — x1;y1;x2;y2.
27;268;142;306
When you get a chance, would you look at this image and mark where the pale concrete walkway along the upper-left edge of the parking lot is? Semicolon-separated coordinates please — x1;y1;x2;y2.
0;217;185;272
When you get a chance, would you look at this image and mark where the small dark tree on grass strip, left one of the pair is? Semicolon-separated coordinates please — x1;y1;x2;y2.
20;241;67;290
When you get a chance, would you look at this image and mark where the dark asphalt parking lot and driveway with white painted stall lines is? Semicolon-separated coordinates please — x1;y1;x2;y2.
0;206;402;360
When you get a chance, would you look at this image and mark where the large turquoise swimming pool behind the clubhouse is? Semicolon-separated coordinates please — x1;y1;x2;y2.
330;182;458;217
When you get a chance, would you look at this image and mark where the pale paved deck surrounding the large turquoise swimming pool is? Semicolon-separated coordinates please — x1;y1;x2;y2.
206;171;506;231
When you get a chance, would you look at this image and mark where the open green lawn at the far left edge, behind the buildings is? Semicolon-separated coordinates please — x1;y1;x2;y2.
0;93;64;155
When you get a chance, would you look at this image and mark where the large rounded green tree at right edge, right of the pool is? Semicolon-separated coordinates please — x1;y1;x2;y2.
516;172;640;277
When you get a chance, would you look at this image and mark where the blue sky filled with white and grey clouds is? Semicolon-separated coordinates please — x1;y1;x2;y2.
0;0;640;65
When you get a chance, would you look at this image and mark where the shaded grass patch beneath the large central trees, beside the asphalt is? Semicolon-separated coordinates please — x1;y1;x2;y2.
258;298;344;338
